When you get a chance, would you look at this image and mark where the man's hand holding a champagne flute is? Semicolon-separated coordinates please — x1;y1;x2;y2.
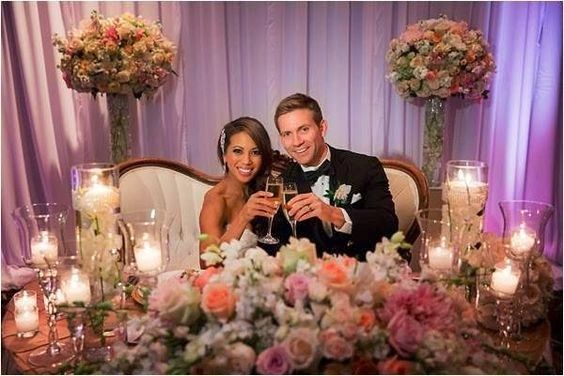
288;193;345;228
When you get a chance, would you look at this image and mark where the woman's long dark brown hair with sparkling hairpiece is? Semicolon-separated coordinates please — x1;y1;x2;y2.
217;116;272;194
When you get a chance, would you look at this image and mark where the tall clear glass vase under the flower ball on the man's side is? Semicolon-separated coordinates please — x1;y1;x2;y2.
422;97;445;187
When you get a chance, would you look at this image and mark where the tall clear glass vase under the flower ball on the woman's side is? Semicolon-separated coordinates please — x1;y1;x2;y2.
106;94;131;164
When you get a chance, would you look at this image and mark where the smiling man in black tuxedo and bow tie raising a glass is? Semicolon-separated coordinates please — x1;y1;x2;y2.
273;93;398;260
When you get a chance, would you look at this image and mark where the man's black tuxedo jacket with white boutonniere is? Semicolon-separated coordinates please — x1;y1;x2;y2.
273;147;398;260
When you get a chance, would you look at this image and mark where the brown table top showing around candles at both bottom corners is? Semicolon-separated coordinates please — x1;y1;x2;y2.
2;281;550;374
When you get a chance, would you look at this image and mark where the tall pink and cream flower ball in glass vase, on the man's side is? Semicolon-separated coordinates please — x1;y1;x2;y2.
386;16;495;186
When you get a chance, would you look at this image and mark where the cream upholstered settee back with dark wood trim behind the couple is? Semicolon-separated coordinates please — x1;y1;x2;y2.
119;159;429;270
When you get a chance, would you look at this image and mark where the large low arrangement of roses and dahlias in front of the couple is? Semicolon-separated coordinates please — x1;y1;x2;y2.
80;233;503;374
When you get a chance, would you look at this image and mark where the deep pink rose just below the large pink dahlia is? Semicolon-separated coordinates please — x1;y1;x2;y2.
388;311;423;356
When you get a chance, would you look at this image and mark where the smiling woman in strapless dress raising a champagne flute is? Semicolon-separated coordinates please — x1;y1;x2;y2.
200;117;277;260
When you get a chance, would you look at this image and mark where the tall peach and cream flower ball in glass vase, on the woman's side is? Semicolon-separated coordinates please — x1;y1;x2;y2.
53;11;176;163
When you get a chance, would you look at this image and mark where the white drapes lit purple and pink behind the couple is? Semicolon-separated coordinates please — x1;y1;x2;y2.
2;2;562;263
